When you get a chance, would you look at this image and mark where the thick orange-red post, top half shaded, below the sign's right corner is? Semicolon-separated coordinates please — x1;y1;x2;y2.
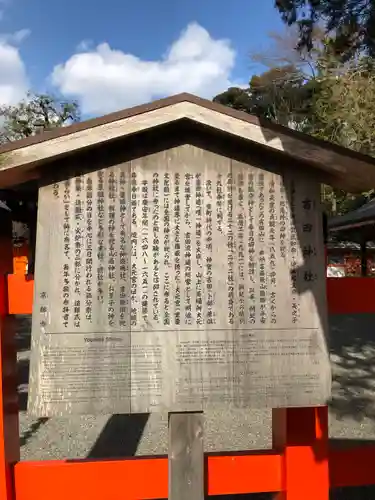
272;406;329;500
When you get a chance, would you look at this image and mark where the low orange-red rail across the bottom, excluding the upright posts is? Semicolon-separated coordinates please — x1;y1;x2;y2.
15;446;375;500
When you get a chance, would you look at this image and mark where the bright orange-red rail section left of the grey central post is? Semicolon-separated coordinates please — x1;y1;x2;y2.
15;459;168;500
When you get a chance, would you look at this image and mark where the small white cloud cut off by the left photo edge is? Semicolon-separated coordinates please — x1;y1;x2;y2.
0;38;28;105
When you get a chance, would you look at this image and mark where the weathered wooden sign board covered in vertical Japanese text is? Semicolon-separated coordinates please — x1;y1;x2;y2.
29;145;331;416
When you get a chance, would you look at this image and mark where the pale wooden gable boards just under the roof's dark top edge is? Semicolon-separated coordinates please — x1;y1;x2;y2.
0;101;374;190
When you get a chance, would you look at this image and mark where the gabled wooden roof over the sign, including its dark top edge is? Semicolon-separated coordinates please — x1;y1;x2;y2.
0;94;375;191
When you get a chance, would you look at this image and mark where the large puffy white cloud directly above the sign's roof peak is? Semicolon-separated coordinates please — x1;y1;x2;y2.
52;23;236;114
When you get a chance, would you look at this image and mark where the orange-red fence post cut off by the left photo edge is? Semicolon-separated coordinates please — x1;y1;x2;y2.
0;218;20;500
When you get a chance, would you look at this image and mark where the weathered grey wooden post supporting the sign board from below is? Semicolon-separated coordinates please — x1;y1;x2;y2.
168;413;204;500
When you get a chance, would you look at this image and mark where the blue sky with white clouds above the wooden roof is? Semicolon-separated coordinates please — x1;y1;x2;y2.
0;0;283;116
